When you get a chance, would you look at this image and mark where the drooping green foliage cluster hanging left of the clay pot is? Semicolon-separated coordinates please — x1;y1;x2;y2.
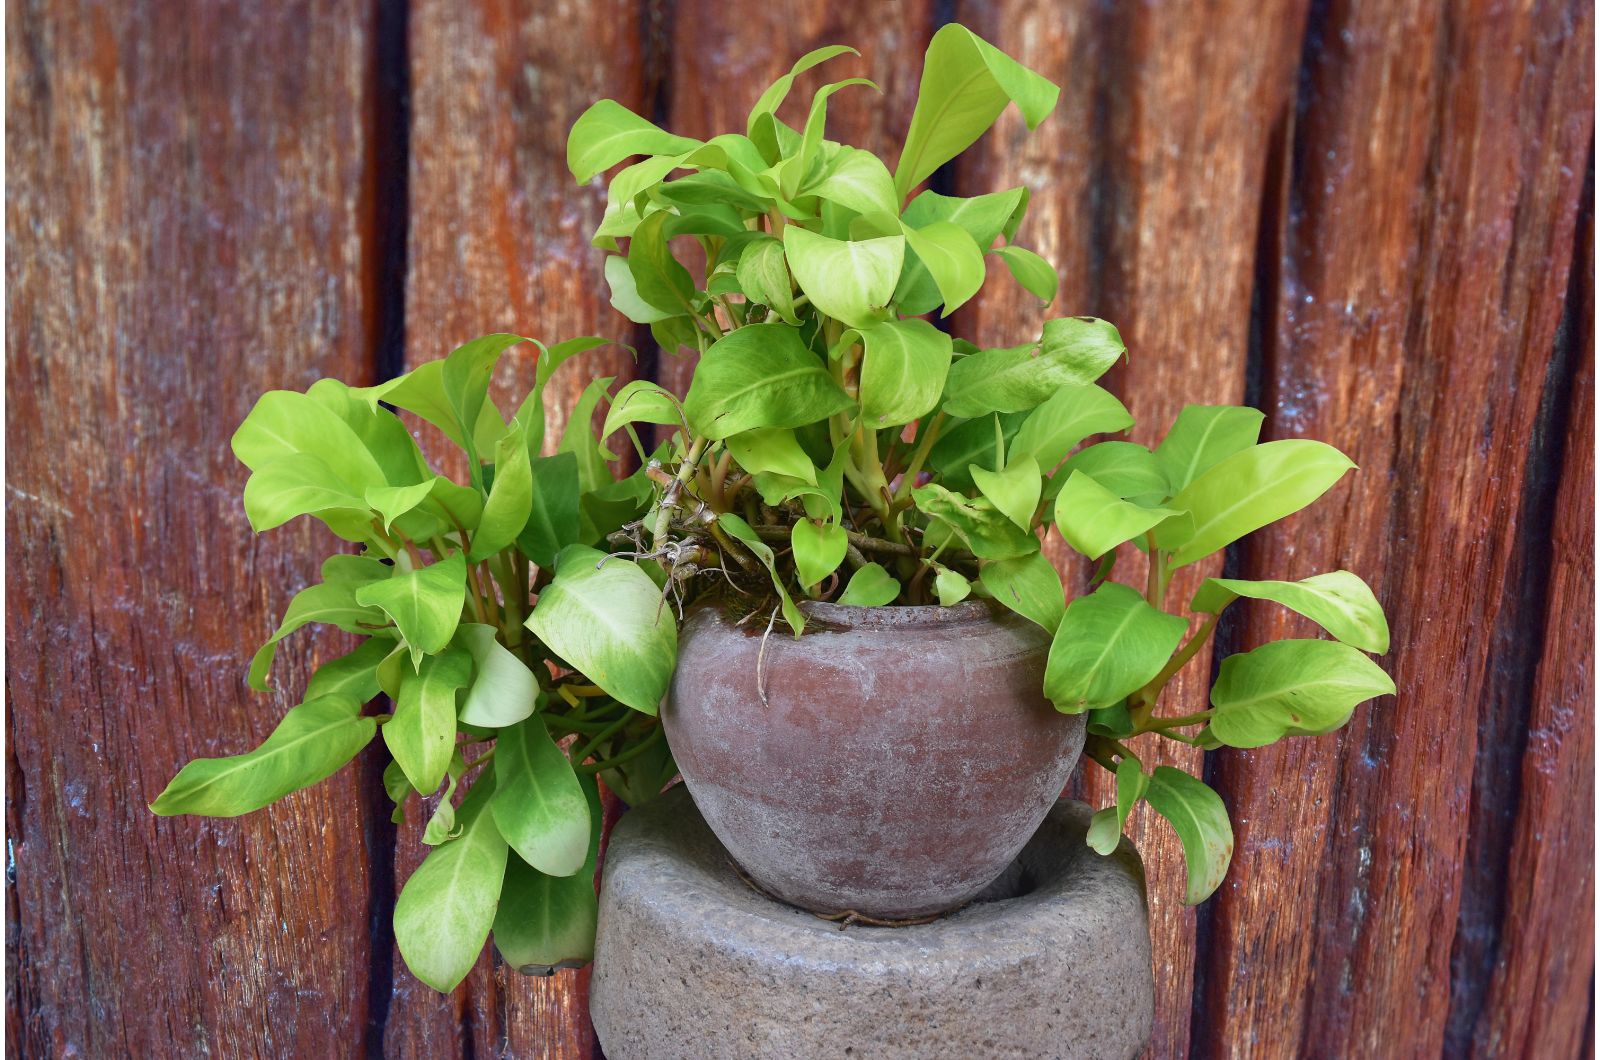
150;335;691;991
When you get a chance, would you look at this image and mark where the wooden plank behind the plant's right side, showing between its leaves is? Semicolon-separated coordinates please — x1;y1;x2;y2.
958;0;1304;1057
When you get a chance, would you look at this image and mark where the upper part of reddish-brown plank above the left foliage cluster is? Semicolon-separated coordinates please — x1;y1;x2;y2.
405;0;651;450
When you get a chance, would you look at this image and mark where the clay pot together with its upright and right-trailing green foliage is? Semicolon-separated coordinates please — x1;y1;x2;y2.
530;26;1394;919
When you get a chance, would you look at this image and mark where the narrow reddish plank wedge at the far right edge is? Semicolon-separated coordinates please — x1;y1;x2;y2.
1470;186;1595;1057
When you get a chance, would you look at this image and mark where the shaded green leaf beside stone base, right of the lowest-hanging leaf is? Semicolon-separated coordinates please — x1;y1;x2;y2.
494;778;600;975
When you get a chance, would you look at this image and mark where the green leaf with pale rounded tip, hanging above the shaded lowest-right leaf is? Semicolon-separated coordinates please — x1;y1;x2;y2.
490;714;590;876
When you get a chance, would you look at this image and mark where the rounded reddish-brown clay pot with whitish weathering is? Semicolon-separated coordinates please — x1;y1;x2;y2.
662;600;1085;919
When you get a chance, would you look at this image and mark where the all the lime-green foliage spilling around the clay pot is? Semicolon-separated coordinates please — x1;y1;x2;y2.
154;26;1394;990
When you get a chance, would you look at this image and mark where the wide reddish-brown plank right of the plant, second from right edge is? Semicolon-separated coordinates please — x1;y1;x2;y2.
1197;2;1592;1057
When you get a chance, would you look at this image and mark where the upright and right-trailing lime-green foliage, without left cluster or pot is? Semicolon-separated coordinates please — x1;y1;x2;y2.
549;26;1394;903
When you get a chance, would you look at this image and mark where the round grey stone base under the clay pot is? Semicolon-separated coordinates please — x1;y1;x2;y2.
590;785;1154;1060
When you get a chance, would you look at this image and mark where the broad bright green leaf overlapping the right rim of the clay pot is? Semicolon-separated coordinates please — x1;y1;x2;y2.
1045;581;1189;714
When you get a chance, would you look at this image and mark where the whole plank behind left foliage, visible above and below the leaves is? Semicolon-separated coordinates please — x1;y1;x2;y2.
384;0;651;1057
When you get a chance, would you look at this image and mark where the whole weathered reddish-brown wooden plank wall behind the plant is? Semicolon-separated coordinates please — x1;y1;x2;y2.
5;0;1595;1057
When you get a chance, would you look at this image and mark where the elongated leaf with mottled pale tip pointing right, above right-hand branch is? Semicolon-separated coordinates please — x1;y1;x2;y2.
944;317;1125;418
